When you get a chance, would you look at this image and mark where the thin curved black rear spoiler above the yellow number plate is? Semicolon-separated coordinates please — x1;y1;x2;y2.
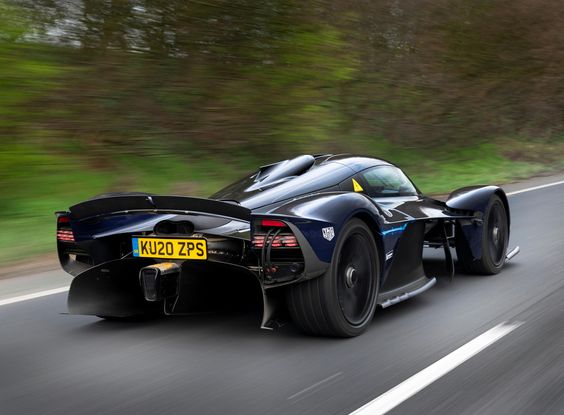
70;195;251;222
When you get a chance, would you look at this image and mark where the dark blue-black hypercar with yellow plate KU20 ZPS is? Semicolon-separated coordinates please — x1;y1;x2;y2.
57;154;518;337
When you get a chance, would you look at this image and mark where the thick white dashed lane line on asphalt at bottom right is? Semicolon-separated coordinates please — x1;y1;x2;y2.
350;322;523;415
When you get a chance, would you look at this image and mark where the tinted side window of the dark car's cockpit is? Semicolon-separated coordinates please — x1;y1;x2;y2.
360;166;417;197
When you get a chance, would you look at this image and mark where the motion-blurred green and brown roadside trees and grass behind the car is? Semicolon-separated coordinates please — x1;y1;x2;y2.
0;0;564;262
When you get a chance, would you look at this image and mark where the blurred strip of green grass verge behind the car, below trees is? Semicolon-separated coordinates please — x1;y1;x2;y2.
0;142;562;265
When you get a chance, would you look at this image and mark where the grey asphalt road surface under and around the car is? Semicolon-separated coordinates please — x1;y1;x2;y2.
0;180;564;415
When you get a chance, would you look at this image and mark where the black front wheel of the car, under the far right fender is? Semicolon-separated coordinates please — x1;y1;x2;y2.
456;195;509;275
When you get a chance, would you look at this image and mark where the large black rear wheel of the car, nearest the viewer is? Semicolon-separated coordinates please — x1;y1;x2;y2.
287;219;380;337
